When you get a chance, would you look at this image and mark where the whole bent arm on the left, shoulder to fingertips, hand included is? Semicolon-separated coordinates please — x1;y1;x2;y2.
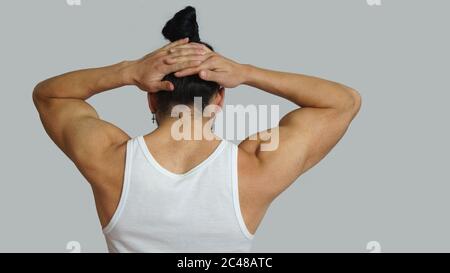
33;36;205;183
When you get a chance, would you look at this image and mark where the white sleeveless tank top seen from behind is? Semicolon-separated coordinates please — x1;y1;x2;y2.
103;136;253;252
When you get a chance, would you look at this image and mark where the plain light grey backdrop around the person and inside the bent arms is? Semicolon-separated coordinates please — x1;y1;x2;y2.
0;0;450;252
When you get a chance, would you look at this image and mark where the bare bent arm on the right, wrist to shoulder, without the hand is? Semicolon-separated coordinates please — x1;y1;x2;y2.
239;65;361;202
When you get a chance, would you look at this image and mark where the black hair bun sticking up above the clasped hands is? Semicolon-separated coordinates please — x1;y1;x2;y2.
162;6;200;42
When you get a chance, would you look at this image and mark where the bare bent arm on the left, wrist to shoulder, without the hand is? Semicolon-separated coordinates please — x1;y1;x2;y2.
33;62;131;170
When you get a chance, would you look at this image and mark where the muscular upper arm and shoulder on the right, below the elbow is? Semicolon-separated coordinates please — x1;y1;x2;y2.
240;107;352;198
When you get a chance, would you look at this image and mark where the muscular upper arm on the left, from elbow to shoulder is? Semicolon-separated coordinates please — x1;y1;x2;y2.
36;96;129;167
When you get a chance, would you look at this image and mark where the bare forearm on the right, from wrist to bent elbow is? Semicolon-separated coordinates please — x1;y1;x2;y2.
244;65;359;109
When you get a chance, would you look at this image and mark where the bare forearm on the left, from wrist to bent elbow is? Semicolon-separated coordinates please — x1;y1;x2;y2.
33;62;132;100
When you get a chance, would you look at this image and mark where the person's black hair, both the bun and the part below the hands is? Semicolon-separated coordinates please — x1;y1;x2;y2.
156;6;220;115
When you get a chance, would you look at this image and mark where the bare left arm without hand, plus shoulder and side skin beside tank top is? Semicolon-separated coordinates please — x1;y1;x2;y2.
33;62;136;226
